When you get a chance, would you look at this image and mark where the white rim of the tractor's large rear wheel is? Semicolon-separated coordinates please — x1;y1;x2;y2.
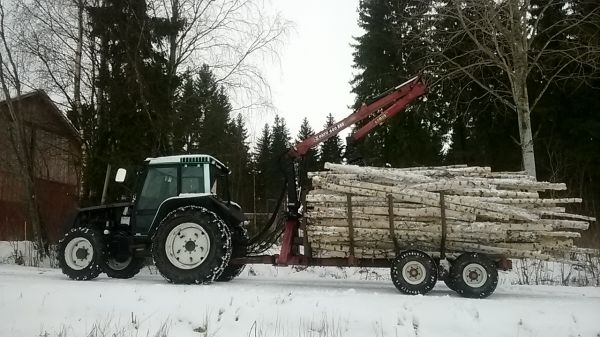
165;222;210;269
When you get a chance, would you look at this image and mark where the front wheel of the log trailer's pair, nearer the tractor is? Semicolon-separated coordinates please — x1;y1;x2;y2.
391;250;438;295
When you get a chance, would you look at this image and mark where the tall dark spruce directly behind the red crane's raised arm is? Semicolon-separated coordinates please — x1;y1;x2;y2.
352;0;447;166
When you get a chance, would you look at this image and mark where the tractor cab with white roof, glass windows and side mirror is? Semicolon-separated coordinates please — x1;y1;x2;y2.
115;154;231;236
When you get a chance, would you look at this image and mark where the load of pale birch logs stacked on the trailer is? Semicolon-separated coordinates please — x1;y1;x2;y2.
305;163;595;260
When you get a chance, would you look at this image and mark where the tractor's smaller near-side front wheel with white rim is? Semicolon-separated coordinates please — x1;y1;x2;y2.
58;227;102;281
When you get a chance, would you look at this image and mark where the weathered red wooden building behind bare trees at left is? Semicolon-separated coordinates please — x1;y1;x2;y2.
0;90;82;242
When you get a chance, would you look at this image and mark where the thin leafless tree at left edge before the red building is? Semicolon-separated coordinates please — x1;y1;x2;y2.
0;3;47;255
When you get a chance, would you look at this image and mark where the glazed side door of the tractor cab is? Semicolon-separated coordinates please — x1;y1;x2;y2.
134;166;178;235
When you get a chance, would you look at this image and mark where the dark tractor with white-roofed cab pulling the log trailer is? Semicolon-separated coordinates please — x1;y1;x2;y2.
58;155;248;284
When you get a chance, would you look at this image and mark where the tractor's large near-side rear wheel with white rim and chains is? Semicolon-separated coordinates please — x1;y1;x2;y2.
152;206;232;284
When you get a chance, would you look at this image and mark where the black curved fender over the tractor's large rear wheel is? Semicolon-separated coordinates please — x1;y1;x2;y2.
148;194;245;237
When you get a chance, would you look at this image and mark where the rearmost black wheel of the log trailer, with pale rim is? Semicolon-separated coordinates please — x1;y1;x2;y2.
449;253;498;298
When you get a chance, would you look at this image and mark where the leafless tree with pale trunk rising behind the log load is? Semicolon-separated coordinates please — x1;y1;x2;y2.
434;0;600;177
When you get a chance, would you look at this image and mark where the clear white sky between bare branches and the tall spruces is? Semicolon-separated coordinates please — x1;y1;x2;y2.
248;0;362;143
